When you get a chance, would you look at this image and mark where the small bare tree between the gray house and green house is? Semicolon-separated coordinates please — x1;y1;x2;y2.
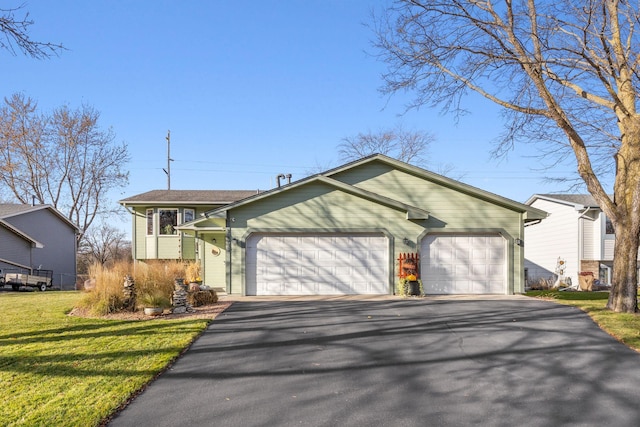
78;222;131;274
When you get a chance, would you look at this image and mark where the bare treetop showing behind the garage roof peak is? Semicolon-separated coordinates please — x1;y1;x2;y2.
338;126;435;166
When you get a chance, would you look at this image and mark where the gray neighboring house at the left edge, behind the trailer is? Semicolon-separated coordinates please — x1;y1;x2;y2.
0;204;79;289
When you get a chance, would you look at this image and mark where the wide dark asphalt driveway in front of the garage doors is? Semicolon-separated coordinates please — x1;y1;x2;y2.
110;298;640;427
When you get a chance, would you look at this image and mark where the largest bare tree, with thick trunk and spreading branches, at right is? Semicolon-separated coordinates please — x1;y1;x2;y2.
375;0;640;312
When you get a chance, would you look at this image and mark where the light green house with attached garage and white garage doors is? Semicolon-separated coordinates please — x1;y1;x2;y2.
121;155;546;295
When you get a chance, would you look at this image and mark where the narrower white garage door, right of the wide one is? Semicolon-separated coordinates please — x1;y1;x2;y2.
421;234;507;295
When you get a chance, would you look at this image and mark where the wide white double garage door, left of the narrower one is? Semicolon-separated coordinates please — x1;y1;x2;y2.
246;234;389;295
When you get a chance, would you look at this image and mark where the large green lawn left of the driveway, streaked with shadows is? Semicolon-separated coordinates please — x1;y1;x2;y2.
0;292;209;427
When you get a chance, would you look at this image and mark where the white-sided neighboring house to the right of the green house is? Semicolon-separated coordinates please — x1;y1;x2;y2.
524;194;615;285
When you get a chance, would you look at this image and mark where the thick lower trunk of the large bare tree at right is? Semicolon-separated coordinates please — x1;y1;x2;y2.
607;222;640;313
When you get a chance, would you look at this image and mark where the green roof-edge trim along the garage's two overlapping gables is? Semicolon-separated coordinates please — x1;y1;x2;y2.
194;154;547;222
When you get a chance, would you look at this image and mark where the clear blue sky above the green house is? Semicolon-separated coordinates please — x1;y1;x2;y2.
0;0;576;231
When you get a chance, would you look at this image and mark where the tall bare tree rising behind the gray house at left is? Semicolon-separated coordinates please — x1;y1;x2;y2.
0;94;129;244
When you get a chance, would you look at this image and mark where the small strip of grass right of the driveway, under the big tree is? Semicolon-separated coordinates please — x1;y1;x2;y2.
525;291;640;351
